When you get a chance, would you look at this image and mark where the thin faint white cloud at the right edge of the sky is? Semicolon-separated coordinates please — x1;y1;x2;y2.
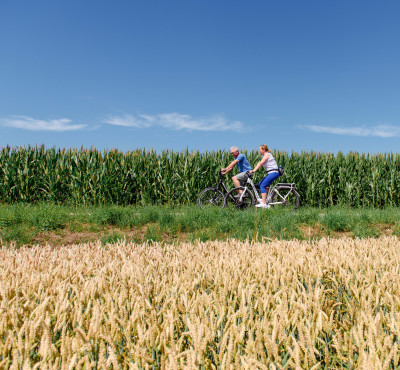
301;125;400;138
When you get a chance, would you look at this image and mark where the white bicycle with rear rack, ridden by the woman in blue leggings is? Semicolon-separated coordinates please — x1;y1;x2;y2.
224;172;300;212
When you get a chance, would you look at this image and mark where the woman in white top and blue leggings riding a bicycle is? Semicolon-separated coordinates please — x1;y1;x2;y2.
250;144;279;208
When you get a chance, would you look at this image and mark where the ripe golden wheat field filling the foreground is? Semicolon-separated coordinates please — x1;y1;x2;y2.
0;237;400;369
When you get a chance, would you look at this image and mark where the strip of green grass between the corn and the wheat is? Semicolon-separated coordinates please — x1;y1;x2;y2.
0;203;400;245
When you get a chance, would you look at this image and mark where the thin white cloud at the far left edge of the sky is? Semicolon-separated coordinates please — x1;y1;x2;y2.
0;116;86;132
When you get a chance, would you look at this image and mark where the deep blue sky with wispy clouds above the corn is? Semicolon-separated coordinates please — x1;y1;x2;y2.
0;0;400;153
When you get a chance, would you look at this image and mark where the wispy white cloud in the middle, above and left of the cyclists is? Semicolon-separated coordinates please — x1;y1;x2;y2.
104;113;245;132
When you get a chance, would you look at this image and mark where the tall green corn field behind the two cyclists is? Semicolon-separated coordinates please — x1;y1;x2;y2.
0;146;400;207
